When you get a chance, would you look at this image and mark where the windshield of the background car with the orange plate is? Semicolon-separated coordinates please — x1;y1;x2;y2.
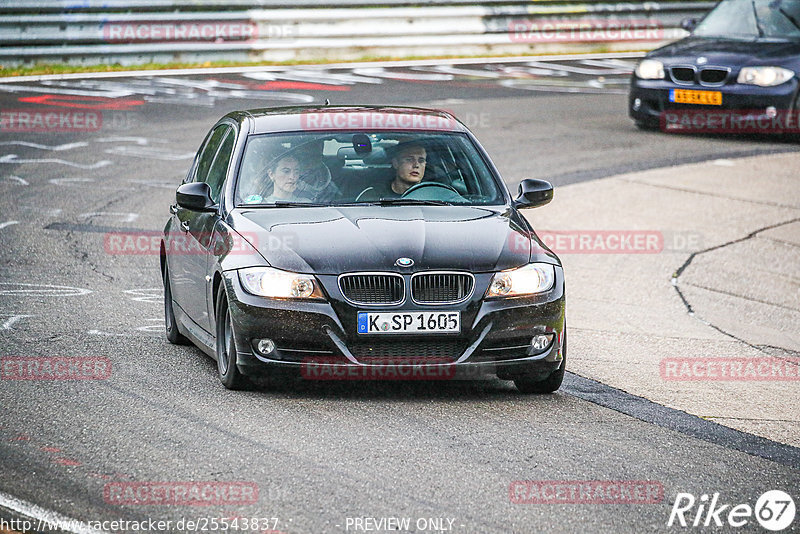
693;0;800;39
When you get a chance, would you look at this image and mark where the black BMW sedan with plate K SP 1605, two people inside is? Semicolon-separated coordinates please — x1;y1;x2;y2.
161;106;566;393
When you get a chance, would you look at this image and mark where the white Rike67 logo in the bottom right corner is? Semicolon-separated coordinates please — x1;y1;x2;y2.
667;490;796;532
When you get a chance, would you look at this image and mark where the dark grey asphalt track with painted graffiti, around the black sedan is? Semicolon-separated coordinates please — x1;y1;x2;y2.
0;59;800;533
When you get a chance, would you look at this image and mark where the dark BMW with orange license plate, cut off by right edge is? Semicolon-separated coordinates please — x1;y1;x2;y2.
628;0;800;133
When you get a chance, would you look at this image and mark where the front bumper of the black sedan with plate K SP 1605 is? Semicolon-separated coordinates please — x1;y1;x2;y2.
224;266;565;380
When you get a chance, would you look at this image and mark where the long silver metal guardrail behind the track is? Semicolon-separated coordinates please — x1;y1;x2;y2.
0;0;714;65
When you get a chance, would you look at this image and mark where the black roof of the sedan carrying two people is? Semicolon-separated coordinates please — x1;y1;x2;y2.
222;105;467;134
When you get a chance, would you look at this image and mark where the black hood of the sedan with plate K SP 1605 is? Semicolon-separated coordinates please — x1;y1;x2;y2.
230;206;558;274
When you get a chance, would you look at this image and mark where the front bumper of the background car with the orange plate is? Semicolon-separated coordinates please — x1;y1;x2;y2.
628;76;798;126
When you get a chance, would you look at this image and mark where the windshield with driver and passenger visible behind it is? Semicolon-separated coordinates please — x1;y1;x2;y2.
236;131;504;207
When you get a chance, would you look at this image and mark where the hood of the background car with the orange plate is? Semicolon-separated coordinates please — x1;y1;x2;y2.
647;37;800;67
